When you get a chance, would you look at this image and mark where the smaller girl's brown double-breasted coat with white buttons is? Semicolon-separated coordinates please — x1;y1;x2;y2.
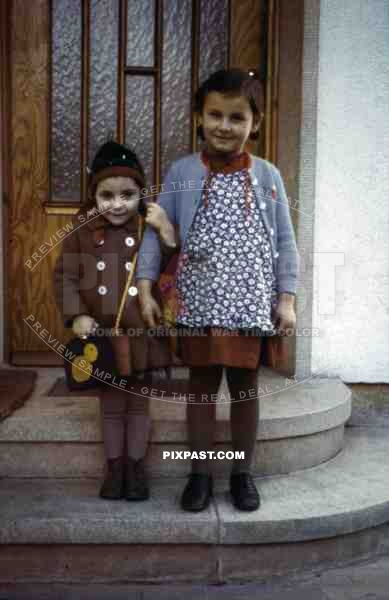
54;211;172;375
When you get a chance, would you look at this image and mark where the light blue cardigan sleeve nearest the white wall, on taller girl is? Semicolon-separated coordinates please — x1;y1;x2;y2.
272;165;299;295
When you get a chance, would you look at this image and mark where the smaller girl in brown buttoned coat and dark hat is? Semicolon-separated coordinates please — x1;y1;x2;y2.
54;141;172;500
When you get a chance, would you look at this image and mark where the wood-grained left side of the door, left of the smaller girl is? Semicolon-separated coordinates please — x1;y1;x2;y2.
8;0;68;352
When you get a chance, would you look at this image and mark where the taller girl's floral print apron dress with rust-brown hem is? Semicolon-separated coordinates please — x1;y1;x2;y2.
176;154;276;368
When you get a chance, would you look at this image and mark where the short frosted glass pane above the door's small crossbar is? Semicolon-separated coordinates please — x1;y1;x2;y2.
127;0;155;67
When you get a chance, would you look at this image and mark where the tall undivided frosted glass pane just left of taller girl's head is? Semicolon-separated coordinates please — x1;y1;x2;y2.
161;0;192;178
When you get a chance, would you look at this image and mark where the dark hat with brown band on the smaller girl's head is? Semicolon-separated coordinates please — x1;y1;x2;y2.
89;141;146;188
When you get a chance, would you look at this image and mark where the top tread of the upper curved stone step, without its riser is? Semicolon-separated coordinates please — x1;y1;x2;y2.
0;369;351;443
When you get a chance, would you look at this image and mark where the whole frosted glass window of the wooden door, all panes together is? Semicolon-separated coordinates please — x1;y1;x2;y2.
51;0;229;204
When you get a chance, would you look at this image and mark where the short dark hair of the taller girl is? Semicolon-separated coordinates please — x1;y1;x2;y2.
194;69;262;140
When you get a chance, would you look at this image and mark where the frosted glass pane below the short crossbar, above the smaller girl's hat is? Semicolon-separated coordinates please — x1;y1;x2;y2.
126;75;155;187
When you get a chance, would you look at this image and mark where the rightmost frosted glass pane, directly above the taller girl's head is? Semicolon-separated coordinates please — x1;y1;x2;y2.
199;0;229;83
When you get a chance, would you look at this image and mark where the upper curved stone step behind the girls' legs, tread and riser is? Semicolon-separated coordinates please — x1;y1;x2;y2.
0;369;351;477
